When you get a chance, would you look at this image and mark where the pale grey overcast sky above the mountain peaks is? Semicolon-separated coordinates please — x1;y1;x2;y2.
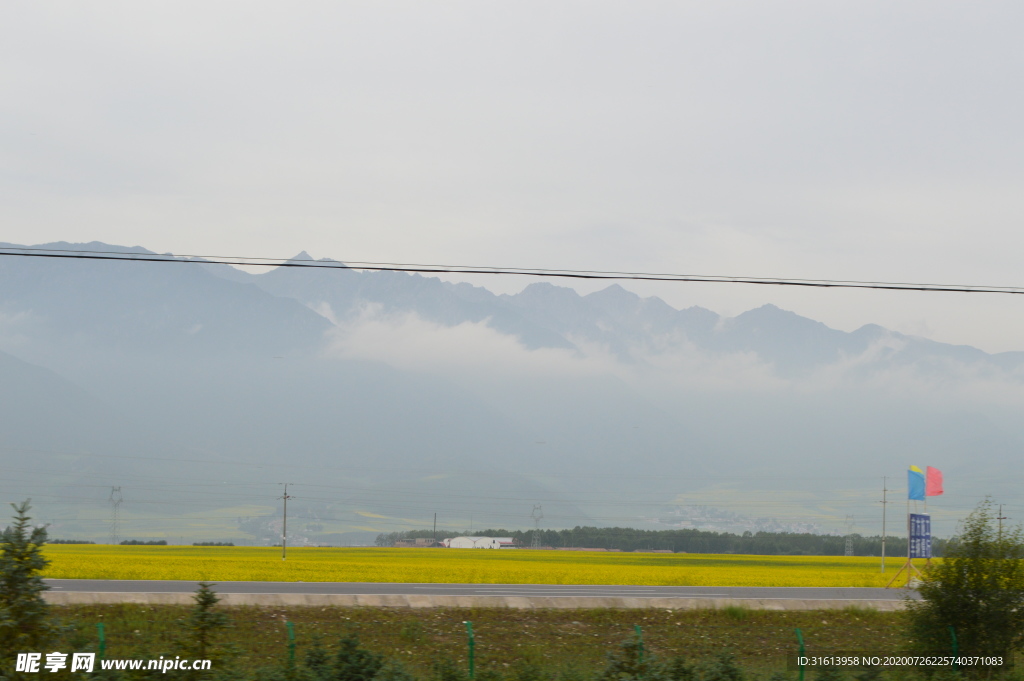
0;0;1024;351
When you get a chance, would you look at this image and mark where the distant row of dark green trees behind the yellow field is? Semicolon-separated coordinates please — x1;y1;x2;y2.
376;525;947;557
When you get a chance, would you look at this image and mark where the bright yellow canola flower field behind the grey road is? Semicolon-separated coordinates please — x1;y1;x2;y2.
44;545;924;587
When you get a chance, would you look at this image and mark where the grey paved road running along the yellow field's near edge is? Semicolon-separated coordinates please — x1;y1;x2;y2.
46;580;906;604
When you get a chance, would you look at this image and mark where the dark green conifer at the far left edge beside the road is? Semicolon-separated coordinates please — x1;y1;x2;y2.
0;501;58;678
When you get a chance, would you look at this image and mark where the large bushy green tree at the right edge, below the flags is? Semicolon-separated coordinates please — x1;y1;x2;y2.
907;499;1024;656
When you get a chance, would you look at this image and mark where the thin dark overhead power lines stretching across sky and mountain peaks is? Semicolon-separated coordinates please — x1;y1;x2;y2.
6;247;1024;295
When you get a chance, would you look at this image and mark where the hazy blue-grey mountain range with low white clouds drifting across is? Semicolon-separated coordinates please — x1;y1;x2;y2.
0;242;1024;541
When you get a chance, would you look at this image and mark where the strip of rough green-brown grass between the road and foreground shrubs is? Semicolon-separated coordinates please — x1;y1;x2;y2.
54;604;917;681
